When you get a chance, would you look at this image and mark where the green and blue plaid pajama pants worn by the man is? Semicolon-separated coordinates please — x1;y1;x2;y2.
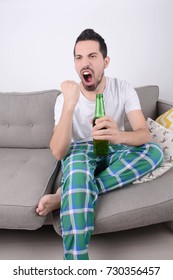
60;142;163;260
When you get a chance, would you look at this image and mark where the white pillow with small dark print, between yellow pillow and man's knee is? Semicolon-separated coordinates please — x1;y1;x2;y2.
147;118;173;162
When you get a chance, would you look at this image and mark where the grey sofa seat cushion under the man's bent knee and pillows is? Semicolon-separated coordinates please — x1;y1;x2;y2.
52;166;173;235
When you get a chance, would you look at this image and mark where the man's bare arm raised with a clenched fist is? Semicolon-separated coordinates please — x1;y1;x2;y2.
50;81;80;160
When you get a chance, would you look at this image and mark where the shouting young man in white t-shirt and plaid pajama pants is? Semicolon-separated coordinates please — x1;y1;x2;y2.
36;29;163;260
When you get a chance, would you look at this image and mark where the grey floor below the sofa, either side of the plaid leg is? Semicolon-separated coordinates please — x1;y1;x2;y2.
0;224;173;260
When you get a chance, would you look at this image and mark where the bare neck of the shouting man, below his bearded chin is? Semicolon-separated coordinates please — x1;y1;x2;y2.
80;77;106;101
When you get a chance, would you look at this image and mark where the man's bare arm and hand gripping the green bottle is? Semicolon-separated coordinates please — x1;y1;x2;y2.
93;110;150;146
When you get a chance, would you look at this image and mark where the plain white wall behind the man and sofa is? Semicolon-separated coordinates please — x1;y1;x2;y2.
0;0;173;101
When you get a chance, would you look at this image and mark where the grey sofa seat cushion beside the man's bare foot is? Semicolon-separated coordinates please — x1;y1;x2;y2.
0;148;56;230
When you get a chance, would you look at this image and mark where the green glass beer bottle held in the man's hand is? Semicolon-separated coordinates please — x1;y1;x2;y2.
93;93;109;156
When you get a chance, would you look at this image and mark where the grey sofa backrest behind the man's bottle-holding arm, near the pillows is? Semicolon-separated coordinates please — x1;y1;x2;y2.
125;86;159;130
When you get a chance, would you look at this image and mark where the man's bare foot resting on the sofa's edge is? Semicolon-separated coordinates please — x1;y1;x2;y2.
36;188;61;216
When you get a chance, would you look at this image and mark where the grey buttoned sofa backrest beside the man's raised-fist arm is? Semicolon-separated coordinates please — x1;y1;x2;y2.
0;90;60;148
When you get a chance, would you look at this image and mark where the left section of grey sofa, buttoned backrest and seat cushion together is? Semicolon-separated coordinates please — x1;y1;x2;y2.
0;90;59;230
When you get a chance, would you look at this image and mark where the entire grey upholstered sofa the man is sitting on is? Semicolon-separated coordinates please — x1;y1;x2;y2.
0;86;173;234
